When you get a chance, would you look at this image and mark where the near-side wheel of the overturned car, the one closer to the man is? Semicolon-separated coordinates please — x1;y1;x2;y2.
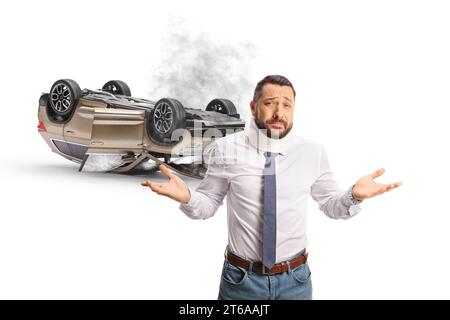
147;98;186;145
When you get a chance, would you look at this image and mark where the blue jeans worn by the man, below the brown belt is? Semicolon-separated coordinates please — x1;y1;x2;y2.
218;252;312;300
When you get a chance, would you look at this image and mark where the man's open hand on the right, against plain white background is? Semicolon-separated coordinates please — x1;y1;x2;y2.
352;168;402;200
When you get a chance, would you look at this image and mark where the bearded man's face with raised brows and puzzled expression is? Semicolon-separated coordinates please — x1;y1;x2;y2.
250;83;295;139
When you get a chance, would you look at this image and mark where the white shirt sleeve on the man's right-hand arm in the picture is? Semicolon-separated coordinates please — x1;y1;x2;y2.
311;147;362;219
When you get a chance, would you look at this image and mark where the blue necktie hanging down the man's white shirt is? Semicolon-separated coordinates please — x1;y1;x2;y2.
262;152;278;269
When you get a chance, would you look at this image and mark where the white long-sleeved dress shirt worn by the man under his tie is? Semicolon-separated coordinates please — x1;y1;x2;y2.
180;117;361;263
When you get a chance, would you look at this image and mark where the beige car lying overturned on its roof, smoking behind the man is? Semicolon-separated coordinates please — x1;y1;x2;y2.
38;79;245;179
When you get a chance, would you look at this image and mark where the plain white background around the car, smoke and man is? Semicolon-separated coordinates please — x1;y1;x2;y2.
0;0;450;299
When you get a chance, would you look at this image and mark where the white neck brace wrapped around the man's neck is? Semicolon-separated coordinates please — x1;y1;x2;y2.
245;116;292;156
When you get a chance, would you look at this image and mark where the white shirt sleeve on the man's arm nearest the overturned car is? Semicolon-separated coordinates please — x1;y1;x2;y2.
180;142;229;219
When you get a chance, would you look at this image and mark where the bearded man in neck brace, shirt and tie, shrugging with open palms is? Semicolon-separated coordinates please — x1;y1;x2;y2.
142;75;401;299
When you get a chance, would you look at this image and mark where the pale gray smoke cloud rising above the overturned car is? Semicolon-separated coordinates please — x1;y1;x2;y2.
150;22;256;114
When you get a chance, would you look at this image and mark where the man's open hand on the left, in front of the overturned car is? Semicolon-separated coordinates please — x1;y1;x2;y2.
141;165;191;202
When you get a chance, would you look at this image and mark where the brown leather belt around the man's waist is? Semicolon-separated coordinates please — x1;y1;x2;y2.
226;251;308;275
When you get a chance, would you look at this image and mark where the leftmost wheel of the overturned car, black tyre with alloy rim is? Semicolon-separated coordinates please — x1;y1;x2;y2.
49;79;81;116
